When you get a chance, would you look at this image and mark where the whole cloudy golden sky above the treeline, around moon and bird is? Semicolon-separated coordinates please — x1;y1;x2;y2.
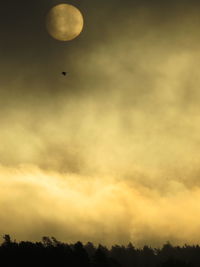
0;0;200;246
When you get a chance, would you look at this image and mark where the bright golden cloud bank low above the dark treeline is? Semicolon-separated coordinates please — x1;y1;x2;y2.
0;166;200;249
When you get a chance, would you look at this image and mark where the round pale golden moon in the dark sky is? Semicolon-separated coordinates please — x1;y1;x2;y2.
46;4;84;41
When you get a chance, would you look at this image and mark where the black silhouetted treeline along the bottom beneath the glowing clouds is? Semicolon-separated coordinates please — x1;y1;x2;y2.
0;235;197;267
